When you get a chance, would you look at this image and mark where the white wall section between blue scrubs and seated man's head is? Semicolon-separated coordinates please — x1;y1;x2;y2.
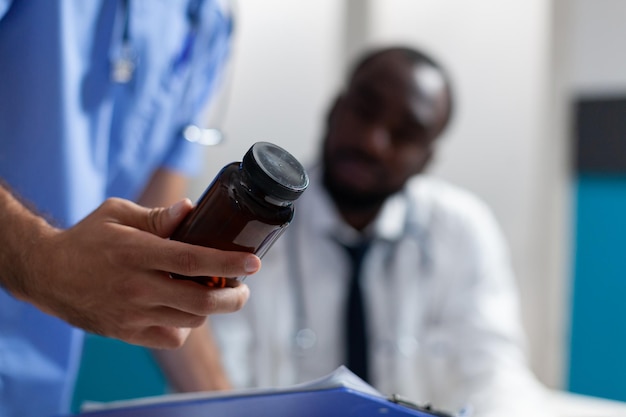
192;0;345;191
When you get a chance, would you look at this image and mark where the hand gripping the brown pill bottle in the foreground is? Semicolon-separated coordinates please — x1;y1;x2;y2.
1;195;260;348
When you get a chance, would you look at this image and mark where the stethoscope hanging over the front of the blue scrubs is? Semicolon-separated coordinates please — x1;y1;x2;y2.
110;0;230;146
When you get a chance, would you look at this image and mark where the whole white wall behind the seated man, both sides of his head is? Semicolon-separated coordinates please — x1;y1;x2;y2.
194;0;568;386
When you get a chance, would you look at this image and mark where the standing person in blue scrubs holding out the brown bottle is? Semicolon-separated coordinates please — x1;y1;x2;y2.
0;0;260;417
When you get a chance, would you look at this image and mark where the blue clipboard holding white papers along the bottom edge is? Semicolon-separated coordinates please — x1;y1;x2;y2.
70;367;453;417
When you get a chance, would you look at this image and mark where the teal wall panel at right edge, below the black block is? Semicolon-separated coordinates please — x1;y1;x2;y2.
569;174;626;401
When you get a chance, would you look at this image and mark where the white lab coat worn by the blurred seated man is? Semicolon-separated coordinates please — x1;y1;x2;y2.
212;165;549;416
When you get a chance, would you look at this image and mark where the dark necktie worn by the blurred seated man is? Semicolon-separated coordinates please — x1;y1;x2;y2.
343;242;369;381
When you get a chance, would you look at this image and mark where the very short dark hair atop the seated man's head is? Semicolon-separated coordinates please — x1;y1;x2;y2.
345;45;454;130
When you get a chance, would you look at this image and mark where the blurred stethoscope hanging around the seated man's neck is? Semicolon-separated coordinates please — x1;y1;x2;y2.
284;188;433;357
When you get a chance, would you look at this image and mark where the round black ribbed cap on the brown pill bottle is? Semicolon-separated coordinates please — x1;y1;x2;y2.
241;142;309;201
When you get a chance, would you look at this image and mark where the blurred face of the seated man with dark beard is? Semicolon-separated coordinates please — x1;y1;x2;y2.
323;52;450;207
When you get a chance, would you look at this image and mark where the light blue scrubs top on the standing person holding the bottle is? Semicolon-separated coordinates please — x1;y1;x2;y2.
0;0;232;417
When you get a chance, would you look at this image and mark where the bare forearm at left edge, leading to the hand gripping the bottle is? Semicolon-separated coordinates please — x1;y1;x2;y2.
0;184;55;299
